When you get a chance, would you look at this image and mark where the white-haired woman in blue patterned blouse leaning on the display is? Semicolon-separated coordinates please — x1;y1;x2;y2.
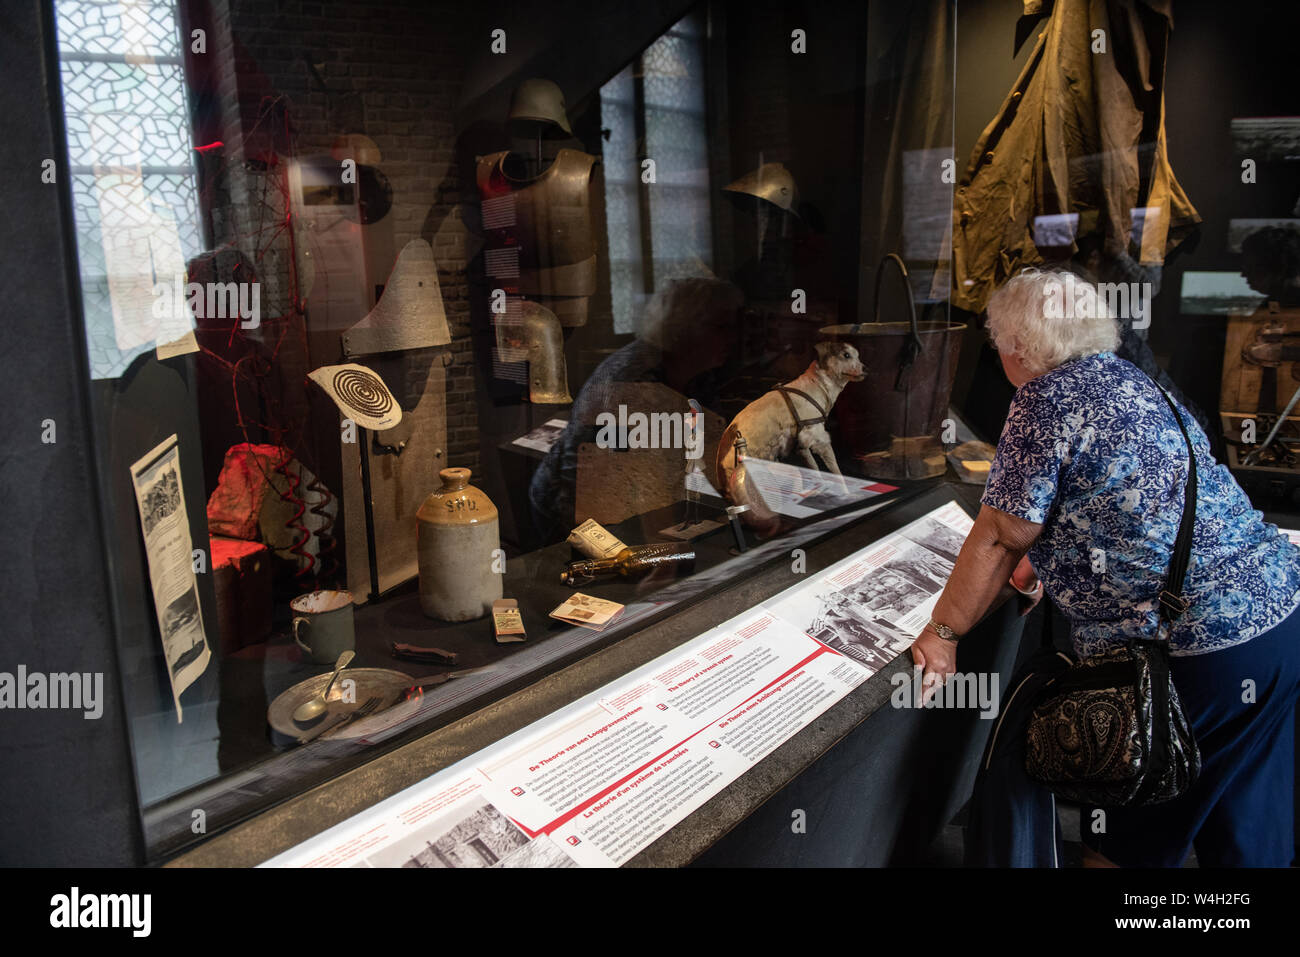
913;269;1300;867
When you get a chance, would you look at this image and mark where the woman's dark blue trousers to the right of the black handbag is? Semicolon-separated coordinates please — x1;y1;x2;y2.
1082;610;1300;867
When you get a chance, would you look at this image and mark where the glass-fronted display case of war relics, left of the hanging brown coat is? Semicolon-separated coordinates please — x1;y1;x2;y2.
45;0;966;859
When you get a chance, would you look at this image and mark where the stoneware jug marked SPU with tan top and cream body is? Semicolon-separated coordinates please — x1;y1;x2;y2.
416;468;504;622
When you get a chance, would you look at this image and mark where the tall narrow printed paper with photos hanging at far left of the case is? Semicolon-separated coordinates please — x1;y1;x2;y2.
131;436;212;724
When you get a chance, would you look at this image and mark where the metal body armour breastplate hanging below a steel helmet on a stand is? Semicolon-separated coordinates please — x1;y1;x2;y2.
477;150;595;325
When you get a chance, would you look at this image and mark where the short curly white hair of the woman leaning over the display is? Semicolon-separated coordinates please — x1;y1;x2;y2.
988;268;1119;376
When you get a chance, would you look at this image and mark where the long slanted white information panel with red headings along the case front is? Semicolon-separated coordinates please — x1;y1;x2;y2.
265;502;971;867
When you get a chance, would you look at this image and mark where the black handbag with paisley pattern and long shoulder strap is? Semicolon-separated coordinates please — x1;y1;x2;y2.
1024;389;1201;807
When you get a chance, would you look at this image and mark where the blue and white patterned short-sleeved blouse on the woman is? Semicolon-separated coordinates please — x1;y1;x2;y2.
983;352;1300;655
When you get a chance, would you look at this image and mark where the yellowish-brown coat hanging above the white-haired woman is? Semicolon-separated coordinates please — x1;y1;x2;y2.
953;0;1201;312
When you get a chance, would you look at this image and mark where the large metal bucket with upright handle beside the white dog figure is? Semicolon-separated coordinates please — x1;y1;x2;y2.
820;252;966;479
